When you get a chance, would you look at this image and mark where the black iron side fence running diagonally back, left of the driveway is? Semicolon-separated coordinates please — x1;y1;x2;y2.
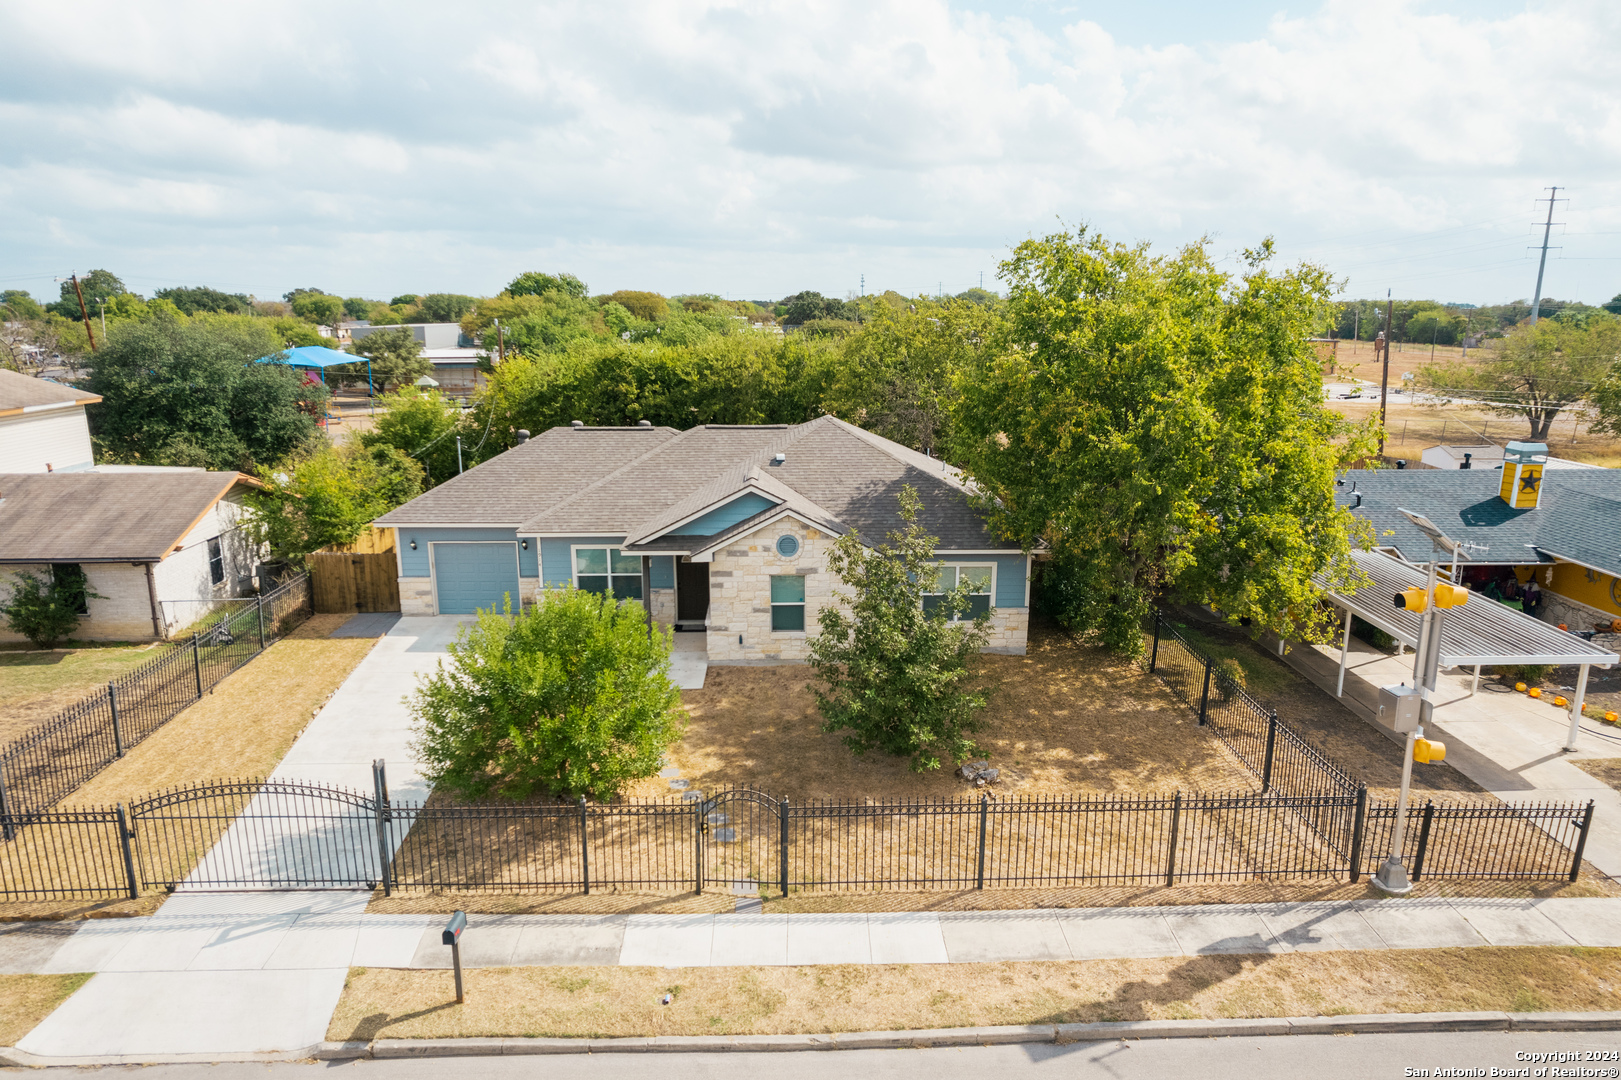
0;574;311;823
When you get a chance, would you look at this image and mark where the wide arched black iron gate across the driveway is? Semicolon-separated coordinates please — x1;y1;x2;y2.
130;780;381;892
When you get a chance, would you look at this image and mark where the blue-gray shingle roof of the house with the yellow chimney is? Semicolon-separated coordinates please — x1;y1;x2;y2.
1337;469;1621;576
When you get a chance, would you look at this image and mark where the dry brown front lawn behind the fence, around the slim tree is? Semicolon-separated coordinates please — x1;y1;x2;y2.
626;626;1256;801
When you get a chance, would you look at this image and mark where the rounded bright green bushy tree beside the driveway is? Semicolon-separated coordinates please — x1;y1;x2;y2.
412;589;684;799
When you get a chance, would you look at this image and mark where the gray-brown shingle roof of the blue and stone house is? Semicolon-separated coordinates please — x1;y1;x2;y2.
378;417;1016;551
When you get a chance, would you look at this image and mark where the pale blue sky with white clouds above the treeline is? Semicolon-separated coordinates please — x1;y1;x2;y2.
0;0;1621;303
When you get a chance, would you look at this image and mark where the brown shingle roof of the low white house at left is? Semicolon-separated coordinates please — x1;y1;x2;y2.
0;472;256;563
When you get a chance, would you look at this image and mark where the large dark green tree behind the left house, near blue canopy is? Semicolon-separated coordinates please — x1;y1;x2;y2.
84;306;326;472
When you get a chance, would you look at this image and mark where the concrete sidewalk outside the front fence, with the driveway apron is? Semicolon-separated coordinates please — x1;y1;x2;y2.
0;892;1621;1057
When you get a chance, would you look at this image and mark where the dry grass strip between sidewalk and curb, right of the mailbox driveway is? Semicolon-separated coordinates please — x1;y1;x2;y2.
327;947;1621;1039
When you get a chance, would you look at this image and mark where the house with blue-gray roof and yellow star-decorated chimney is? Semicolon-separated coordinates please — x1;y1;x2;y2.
1337;443;1621;631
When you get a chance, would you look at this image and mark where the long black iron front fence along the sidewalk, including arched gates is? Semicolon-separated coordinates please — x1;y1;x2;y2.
0;770;1593;900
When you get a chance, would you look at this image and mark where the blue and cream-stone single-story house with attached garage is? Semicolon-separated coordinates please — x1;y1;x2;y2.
376;417;1029;663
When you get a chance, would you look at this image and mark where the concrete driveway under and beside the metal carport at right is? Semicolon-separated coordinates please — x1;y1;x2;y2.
1285;637;1621;877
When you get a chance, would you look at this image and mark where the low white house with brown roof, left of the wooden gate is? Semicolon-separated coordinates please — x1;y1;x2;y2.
0;469;263;641
